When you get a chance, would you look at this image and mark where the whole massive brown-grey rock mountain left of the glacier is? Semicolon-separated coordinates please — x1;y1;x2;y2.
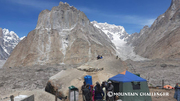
4;2;115;67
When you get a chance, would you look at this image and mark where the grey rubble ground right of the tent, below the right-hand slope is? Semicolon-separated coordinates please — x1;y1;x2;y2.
127;59;180;86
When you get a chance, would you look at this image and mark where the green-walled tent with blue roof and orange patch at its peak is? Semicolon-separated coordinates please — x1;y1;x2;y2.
109;71;152;101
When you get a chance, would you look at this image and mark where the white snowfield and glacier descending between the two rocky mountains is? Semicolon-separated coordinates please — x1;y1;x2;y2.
91;21;147;61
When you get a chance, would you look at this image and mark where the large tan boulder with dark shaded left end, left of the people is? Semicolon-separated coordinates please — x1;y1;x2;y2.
45;69;84;98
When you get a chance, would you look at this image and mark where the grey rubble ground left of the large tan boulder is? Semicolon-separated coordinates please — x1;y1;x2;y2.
0;66;64;96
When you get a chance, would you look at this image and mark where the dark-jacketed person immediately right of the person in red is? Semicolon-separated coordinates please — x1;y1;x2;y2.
94;82;104;101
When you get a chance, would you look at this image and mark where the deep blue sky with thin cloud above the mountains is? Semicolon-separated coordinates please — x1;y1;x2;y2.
0;0;171;37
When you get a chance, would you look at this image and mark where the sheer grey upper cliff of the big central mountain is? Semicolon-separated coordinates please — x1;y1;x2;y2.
36;2;89;32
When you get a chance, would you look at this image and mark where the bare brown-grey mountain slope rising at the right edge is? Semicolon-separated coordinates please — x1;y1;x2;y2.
128;0;180;59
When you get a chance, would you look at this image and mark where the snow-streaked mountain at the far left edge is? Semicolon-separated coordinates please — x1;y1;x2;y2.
0;28;21;60
